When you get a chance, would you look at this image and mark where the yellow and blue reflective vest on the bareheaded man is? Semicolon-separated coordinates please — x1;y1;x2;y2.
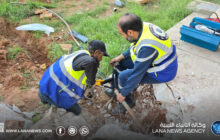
130;22;178;81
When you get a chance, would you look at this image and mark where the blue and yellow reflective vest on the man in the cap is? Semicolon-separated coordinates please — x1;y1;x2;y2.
40;50;90;109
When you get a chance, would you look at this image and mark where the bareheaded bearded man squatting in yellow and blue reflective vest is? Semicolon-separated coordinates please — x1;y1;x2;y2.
105;13;178;114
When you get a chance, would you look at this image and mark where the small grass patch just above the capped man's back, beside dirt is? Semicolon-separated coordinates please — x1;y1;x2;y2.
48;43;66;62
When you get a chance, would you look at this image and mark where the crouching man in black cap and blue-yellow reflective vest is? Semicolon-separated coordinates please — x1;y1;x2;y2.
39;40;109;115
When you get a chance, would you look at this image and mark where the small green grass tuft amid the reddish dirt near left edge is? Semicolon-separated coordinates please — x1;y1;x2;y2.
7;46;24;59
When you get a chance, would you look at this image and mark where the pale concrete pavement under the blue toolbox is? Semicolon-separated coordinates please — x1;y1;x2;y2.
154;0;220;139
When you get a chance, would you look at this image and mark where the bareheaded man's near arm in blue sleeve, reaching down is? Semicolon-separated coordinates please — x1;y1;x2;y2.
121;47;158;97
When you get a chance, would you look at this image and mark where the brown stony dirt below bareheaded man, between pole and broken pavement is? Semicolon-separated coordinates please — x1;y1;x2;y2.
133;85;167;133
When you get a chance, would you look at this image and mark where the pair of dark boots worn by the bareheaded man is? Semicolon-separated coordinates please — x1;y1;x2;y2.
112;95;135;115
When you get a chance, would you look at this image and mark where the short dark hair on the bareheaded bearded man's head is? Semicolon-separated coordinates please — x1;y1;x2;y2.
118;13;143;34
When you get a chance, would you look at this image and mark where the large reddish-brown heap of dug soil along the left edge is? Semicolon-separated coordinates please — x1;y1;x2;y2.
0;18;52;111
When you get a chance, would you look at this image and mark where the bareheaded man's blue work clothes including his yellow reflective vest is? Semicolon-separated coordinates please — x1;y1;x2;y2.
112;23;178;97
